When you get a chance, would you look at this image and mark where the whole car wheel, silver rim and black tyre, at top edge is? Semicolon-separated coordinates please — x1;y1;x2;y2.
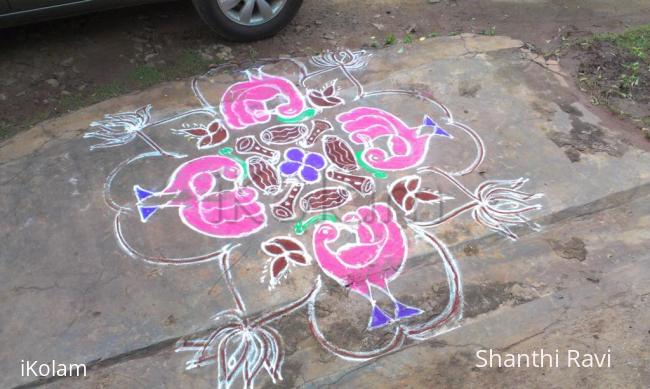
192;0;303;42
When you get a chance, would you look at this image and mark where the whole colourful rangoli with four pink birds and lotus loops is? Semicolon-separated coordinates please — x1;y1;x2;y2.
86;50;541;388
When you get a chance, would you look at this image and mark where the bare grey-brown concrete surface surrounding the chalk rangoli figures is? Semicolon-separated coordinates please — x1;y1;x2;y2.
0;34;650;388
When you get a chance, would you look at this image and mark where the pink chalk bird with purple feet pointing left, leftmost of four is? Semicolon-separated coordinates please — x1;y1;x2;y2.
133;155;266;238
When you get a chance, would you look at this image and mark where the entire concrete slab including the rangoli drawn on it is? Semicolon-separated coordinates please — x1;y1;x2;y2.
0;35;650;388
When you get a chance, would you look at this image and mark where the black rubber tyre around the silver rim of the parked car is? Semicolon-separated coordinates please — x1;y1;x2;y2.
192;0;303;42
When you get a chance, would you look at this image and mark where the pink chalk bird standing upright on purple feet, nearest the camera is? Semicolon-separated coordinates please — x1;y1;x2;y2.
313;203;422;329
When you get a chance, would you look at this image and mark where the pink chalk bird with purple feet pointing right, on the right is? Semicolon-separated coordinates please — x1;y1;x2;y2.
336;107;452;170
